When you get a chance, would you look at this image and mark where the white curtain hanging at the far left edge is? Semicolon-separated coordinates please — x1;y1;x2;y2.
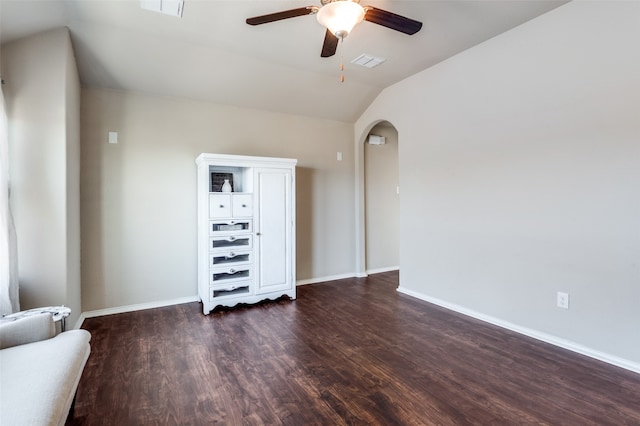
0;84;20;315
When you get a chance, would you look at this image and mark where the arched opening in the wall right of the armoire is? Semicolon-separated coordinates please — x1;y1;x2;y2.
356;120;400;276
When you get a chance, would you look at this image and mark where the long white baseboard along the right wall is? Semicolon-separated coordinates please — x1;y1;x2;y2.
397;287;640;373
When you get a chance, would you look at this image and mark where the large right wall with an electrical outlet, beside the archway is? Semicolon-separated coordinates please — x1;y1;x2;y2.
355;1;640;371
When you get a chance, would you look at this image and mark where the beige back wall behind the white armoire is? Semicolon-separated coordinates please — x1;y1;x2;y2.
81;89;354;311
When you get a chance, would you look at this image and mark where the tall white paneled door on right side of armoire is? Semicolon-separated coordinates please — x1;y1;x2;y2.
254;168;293;294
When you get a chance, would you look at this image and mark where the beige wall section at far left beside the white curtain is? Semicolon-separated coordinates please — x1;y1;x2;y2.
2;29;81;323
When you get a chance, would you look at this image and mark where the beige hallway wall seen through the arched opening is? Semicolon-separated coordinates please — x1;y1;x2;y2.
364;122;400;273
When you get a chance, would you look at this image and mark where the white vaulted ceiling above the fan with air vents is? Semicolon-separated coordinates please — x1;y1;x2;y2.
0;0;566;122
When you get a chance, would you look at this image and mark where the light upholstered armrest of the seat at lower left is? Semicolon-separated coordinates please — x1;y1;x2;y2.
0;313;56;349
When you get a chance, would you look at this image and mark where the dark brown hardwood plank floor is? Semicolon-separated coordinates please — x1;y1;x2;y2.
67;272;640;425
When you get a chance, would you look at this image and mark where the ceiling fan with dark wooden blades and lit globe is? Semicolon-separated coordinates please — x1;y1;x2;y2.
247;0;422;58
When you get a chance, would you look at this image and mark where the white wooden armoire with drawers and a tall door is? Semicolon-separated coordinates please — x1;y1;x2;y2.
196;153;297;314
